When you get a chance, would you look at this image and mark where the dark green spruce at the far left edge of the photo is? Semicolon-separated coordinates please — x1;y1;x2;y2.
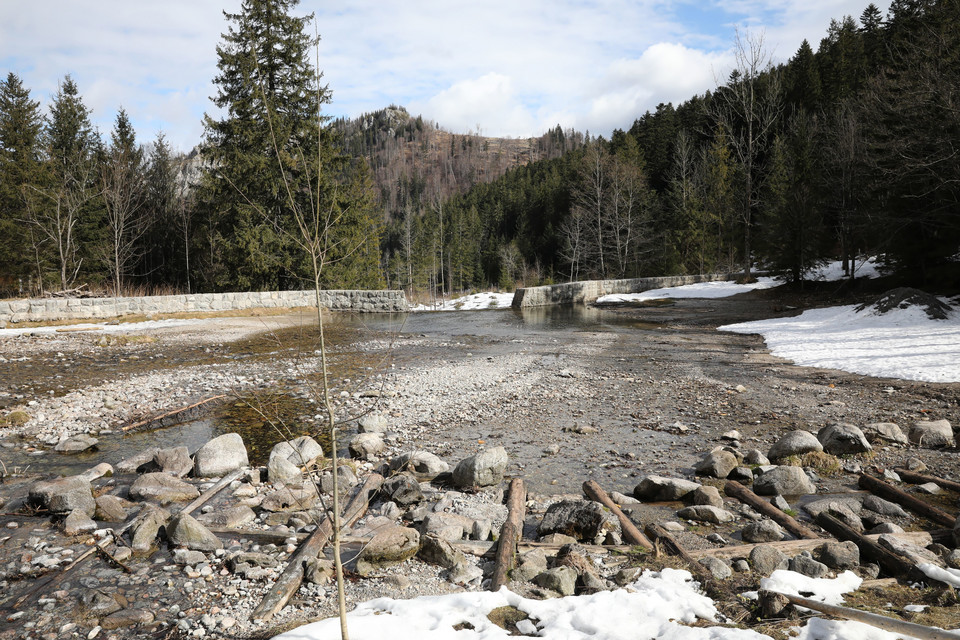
0;72;43;292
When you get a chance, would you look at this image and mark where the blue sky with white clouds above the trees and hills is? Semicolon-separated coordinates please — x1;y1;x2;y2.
0;0;883;151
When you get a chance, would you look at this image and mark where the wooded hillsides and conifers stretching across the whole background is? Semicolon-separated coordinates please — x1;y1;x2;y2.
0;0;960;296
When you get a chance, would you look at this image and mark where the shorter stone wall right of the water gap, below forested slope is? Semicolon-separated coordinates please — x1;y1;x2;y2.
513;273;739;308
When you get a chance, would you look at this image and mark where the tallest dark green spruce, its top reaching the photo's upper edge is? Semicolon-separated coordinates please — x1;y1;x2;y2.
200;0;332;289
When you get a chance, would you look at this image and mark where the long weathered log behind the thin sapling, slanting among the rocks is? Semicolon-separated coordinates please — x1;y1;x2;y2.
250;473;383;620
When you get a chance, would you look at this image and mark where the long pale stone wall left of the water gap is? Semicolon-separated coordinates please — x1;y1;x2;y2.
0;290;408;326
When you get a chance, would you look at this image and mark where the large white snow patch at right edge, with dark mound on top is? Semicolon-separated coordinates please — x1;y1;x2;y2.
718;298;960;382
